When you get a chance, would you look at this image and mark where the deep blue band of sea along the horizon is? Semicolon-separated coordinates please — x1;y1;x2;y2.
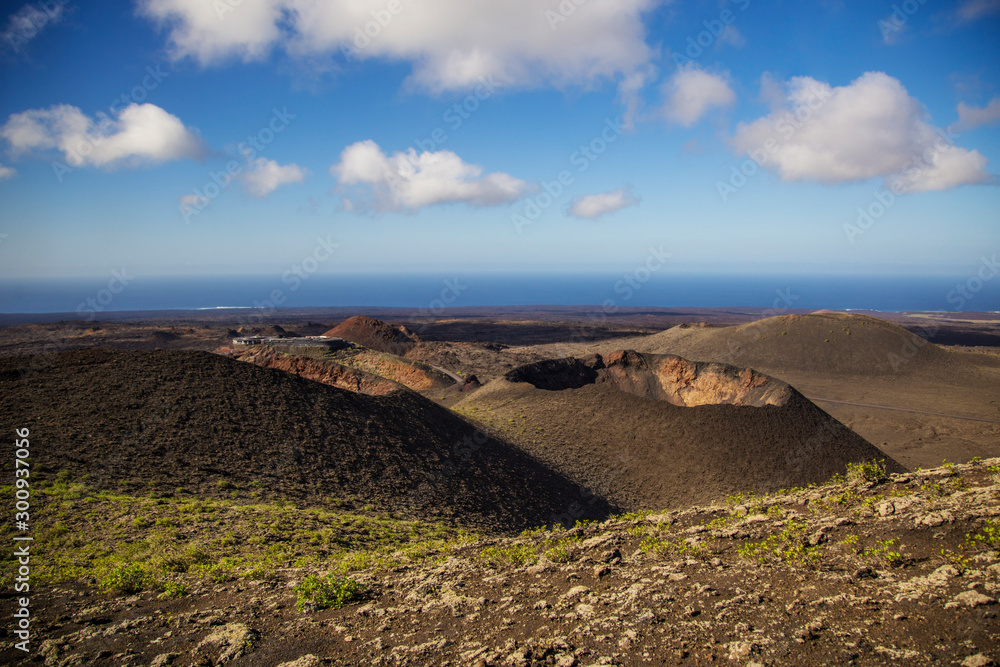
0;273;1000;318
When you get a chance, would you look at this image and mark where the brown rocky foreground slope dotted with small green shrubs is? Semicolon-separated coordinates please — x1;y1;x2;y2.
13;459;1000;667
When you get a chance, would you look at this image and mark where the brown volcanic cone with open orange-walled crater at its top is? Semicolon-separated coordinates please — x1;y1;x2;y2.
456;351;902;509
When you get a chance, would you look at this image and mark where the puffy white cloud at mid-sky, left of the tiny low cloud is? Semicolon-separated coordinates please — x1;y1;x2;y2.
330;140;528;211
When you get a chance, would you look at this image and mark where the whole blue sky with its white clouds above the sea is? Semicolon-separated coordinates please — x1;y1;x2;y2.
0;0;1000;279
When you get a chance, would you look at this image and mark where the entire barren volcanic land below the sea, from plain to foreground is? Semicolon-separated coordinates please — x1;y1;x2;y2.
0;307;1000;667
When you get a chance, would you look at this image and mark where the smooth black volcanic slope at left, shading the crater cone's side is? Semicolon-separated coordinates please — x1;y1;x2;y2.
0;350;607;531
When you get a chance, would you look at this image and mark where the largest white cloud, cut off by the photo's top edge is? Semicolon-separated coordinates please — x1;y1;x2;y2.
140;0;666;92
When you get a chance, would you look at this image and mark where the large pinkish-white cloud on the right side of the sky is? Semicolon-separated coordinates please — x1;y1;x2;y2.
732;72;994;192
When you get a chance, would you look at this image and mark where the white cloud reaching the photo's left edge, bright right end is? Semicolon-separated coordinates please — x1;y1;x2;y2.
0;104;205;167
